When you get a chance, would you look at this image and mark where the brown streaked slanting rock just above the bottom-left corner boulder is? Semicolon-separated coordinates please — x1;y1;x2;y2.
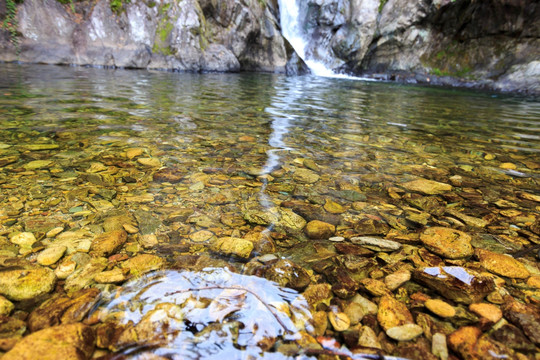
28;288;100;332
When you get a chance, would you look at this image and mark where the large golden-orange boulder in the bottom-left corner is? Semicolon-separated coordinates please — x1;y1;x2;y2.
2;323;95;360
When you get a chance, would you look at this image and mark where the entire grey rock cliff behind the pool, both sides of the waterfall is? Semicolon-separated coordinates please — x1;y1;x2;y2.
0;0;540;94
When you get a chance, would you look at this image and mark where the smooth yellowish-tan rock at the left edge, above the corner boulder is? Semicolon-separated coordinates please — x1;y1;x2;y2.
0;268;56;301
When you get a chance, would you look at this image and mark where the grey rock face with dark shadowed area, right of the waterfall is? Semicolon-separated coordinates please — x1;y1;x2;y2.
284;0;540;93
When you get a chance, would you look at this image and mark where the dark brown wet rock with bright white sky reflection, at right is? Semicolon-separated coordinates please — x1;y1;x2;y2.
413;266;495;304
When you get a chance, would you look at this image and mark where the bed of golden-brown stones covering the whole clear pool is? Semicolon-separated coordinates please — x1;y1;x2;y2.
0;68;540;360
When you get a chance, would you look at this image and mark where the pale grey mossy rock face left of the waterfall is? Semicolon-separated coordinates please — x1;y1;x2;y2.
0;0;286;72
